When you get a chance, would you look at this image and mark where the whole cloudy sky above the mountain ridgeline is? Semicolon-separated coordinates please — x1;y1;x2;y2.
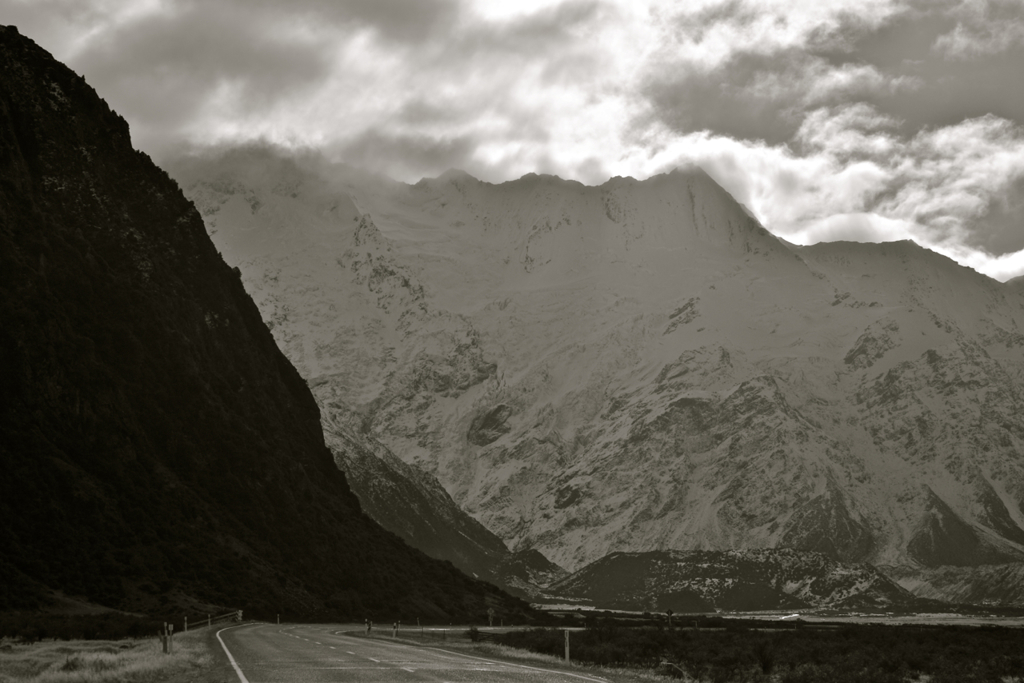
6;0;1024;280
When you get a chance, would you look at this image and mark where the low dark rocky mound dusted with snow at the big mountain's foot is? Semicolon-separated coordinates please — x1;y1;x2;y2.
551;549;928;612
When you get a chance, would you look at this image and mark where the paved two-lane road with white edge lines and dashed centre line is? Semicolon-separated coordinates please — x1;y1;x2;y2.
211;625;607;683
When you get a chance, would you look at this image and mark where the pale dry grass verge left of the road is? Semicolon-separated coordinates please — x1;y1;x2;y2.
0;631;212;683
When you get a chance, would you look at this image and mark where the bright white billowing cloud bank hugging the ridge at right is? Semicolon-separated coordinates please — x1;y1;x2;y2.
613;104;1024;280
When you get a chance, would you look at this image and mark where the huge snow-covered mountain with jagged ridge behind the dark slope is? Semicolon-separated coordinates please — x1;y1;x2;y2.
171;148;1024;602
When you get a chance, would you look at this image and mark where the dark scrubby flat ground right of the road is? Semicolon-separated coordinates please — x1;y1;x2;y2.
496;623;1024;683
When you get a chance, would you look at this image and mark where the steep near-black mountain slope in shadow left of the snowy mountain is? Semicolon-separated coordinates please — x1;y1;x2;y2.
0;28;524;618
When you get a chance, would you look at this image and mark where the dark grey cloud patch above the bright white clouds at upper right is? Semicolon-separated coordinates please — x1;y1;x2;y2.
641;2;1024;143
